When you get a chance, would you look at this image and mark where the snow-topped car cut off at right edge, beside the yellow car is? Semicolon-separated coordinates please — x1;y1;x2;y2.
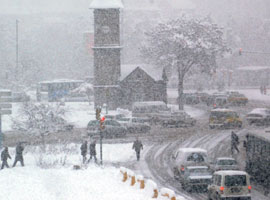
246;108;270;125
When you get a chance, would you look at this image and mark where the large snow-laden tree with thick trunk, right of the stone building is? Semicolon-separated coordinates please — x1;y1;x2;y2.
141;16;227;110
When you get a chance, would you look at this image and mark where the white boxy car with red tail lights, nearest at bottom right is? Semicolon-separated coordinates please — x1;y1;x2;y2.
208;170;251;200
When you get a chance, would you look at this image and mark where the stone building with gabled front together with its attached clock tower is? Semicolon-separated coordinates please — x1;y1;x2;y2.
90;0;167;109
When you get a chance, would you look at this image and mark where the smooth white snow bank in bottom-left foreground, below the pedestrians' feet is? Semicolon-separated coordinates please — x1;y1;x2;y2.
0;166;147;200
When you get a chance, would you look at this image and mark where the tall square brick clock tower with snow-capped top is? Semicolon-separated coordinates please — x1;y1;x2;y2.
90;0;123;109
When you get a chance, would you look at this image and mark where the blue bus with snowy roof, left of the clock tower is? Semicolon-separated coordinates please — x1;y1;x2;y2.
36;79;84;102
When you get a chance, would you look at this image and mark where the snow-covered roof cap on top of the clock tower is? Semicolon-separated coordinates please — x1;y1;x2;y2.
89;0;124;9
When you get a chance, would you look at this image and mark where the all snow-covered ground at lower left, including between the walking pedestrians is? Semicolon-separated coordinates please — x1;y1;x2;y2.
0;144;147;200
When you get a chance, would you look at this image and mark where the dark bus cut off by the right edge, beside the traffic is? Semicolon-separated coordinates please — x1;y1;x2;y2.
244;129;270;190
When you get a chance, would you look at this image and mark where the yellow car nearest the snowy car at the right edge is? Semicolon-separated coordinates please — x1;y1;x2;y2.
209;109;242;129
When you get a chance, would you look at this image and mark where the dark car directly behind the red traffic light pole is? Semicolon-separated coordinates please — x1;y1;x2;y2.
86;119;127;138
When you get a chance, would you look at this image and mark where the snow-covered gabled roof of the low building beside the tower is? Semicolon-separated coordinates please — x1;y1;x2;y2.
120;64;163;81
